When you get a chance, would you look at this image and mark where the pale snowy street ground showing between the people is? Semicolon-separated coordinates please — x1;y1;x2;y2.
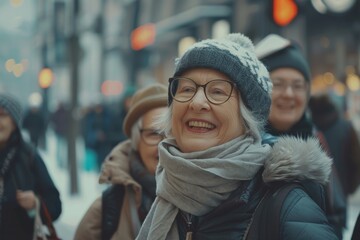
41;131;360;240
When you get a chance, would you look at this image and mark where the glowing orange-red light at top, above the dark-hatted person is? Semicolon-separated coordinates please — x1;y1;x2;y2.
272;0;299;27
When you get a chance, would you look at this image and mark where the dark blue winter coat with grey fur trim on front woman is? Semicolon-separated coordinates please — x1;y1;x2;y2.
176;138;337;240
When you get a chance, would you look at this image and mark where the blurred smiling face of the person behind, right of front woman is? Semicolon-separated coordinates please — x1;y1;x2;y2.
269;68;309;131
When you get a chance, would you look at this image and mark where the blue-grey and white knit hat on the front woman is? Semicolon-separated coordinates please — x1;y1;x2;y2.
169;33;272;121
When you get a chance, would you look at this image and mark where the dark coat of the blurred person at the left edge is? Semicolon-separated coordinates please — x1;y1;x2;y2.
0;133;62;240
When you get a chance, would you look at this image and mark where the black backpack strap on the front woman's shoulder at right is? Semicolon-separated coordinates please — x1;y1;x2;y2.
244;183;302;240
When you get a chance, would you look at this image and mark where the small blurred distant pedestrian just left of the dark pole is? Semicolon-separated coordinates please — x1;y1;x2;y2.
50;103;70;168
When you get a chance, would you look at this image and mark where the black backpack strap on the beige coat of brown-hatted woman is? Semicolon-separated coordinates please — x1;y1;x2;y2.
101;184;125;240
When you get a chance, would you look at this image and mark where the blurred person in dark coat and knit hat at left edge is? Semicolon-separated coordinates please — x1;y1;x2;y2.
0;93;61;240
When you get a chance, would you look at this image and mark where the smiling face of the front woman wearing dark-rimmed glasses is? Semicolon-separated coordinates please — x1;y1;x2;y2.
171;68;245;152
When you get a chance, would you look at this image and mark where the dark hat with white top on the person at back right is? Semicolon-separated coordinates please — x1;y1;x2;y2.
255;34;311;82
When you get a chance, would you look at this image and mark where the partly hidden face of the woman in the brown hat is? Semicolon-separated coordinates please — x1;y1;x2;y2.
138;107;166;175
